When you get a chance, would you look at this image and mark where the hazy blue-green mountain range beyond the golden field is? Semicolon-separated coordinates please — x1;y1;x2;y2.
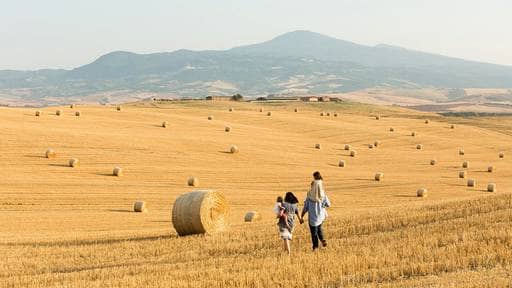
0;31;512;105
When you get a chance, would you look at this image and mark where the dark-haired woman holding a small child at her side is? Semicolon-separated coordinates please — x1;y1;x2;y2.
277;192;302;255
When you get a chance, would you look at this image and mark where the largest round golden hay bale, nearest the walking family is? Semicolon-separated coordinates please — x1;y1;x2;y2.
172;191;229;236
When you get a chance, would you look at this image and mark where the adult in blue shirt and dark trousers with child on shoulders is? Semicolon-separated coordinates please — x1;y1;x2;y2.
301;171;331;251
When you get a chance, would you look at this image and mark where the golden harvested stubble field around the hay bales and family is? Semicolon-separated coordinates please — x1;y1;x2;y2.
0;101;512;287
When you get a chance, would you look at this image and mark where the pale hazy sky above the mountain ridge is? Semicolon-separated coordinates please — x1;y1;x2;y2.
0;0;512;69
